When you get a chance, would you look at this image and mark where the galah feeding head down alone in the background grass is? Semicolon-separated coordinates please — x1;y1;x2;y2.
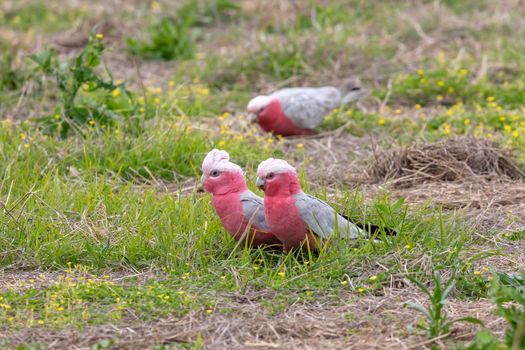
247;85;365;136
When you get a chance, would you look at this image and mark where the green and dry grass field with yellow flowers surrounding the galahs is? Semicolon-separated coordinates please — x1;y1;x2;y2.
0;0;525;349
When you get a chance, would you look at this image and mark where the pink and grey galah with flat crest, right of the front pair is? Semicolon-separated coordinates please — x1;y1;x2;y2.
257;158;395;252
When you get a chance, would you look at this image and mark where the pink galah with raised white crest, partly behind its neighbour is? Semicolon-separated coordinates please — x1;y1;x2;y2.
202;149;281;249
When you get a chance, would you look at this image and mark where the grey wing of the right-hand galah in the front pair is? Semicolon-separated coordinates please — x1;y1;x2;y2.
294;192;366;239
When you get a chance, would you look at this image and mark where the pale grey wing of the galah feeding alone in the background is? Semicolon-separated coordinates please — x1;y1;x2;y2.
273;86;341;129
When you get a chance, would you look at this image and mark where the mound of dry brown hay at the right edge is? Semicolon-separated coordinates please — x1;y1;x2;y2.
365;136;524;187
